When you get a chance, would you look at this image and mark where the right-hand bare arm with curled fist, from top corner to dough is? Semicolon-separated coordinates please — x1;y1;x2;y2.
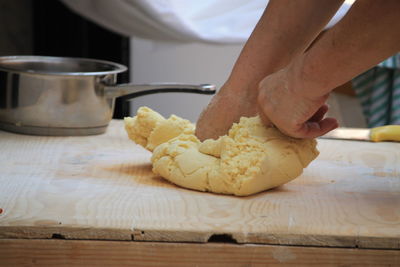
258;0;400;138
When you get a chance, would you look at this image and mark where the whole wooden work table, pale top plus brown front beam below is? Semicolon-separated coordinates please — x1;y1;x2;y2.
0;121;400;266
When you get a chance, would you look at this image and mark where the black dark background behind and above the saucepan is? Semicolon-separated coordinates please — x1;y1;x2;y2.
0;0;130;118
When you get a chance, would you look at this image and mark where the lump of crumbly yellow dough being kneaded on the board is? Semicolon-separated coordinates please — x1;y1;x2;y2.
125;107;319;196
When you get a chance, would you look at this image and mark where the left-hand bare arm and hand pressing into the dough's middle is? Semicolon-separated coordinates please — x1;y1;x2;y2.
196;0;343;140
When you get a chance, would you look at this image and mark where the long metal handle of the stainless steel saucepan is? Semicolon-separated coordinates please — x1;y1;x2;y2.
104;83;216;98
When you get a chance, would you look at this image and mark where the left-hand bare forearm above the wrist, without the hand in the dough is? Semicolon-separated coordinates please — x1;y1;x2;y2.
227;0;343;91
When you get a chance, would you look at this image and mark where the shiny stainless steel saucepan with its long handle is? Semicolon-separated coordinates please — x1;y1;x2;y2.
0;56;215;136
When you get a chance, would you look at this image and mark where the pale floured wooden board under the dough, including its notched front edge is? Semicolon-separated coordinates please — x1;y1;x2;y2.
0;121;400;249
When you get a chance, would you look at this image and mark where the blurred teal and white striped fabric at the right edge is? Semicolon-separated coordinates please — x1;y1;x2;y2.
352;54;400;127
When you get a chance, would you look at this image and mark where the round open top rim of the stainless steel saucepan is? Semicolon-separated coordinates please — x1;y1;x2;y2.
0;55;128;76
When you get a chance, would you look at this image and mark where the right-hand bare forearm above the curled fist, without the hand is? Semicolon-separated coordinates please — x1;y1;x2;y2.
292;0;400;97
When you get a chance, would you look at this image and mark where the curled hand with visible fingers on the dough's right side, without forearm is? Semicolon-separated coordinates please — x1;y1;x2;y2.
257;68;338;138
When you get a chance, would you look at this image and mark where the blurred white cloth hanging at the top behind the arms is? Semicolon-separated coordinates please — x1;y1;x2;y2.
63;0;351;44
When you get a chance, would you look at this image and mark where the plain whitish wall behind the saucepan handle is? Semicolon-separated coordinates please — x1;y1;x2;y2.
130;38;242;122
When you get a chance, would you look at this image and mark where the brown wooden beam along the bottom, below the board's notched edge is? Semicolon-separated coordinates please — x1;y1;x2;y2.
0;239;400;267
